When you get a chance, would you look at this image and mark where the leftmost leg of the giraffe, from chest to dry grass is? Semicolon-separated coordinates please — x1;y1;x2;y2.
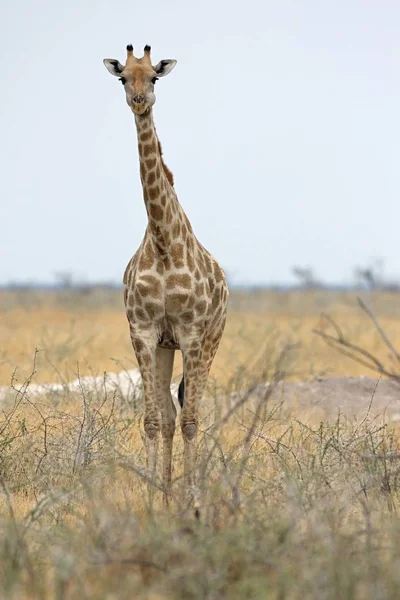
131;327;160;502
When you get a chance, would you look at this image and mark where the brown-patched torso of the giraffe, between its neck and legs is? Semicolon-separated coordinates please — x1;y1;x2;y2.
124;235;227;347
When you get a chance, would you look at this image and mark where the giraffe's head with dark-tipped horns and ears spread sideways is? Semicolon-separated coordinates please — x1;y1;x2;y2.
103;44;176;115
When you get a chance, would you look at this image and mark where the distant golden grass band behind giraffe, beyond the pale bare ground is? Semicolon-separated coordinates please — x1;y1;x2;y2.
0;291;400;385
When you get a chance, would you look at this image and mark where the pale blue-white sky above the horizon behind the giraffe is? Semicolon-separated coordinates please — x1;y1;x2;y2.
0;0;400;283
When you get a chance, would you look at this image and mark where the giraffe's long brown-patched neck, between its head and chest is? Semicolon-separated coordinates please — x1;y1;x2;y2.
135;110;187;256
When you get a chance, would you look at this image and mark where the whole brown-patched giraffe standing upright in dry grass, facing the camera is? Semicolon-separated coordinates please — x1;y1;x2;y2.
103;44;228;504
